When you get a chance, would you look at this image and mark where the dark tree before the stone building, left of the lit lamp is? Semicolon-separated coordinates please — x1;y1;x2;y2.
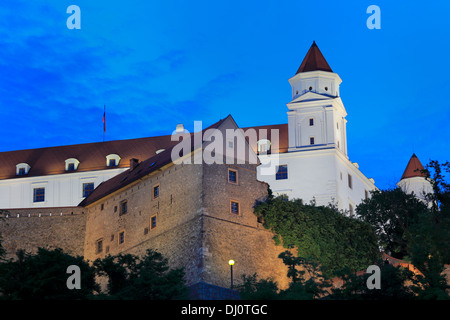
94;250;187;300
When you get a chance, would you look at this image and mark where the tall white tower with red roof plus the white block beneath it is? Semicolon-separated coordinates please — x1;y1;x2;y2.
258;42;376;216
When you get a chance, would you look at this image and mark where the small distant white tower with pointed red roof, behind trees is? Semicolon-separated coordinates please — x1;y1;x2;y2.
397;153;433;200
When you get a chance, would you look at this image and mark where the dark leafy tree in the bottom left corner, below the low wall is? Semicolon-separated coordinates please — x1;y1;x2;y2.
0;248;98;300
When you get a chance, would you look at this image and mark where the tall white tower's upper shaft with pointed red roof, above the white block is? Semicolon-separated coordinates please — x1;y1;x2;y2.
287;42;347;156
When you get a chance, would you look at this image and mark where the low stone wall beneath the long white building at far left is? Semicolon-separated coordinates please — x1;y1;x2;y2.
0;207;86;258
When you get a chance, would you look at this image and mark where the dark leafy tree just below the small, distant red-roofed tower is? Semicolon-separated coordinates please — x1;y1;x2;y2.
356;188;428;259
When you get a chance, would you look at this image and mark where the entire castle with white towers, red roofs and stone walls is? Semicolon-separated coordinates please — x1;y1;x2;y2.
0;42;429;296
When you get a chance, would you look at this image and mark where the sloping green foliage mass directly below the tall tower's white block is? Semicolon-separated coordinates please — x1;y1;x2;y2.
255;196;379;277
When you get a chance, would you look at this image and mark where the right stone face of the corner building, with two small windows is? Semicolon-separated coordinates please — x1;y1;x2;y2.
203;165;288;288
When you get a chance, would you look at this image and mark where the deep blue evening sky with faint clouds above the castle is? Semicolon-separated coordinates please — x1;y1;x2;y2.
0;0;450;189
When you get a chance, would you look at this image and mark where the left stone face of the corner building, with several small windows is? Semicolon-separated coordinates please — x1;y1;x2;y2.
85;164;202;285
